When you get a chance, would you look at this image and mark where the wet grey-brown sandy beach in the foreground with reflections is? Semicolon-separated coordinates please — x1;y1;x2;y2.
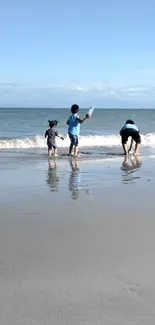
0;155;155;325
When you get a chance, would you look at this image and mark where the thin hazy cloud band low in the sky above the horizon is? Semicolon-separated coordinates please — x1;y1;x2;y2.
0;82;155;106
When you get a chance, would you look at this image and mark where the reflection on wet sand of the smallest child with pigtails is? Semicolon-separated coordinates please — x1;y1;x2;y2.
46;159;59;192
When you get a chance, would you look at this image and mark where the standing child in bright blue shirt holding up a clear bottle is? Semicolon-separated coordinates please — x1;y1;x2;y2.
67;104;90;157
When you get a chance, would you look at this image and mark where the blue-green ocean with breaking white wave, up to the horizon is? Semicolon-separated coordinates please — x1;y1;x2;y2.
0;108;155;155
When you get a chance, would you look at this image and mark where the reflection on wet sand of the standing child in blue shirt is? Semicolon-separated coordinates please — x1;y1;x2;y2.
68;159;81;200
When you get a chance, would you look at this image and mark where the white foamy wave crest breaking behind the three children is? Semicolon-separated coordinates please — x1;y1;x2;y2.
0;133;155;149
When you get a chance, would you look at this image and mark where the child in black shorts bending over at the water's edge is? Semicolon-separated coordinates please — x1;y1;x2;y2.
120;120;141;155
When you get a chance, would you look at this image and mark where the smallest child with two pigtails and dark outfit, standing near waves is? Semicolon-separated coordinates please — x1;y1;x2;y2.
45;120;64;156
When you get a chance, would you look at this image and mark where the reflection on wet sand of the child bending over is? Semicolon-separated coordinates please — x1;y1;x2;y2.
121;156;142;183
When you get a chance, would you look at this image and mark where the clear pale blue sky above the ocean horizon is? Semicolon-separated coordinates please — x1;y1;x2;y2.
0;0;155;108
